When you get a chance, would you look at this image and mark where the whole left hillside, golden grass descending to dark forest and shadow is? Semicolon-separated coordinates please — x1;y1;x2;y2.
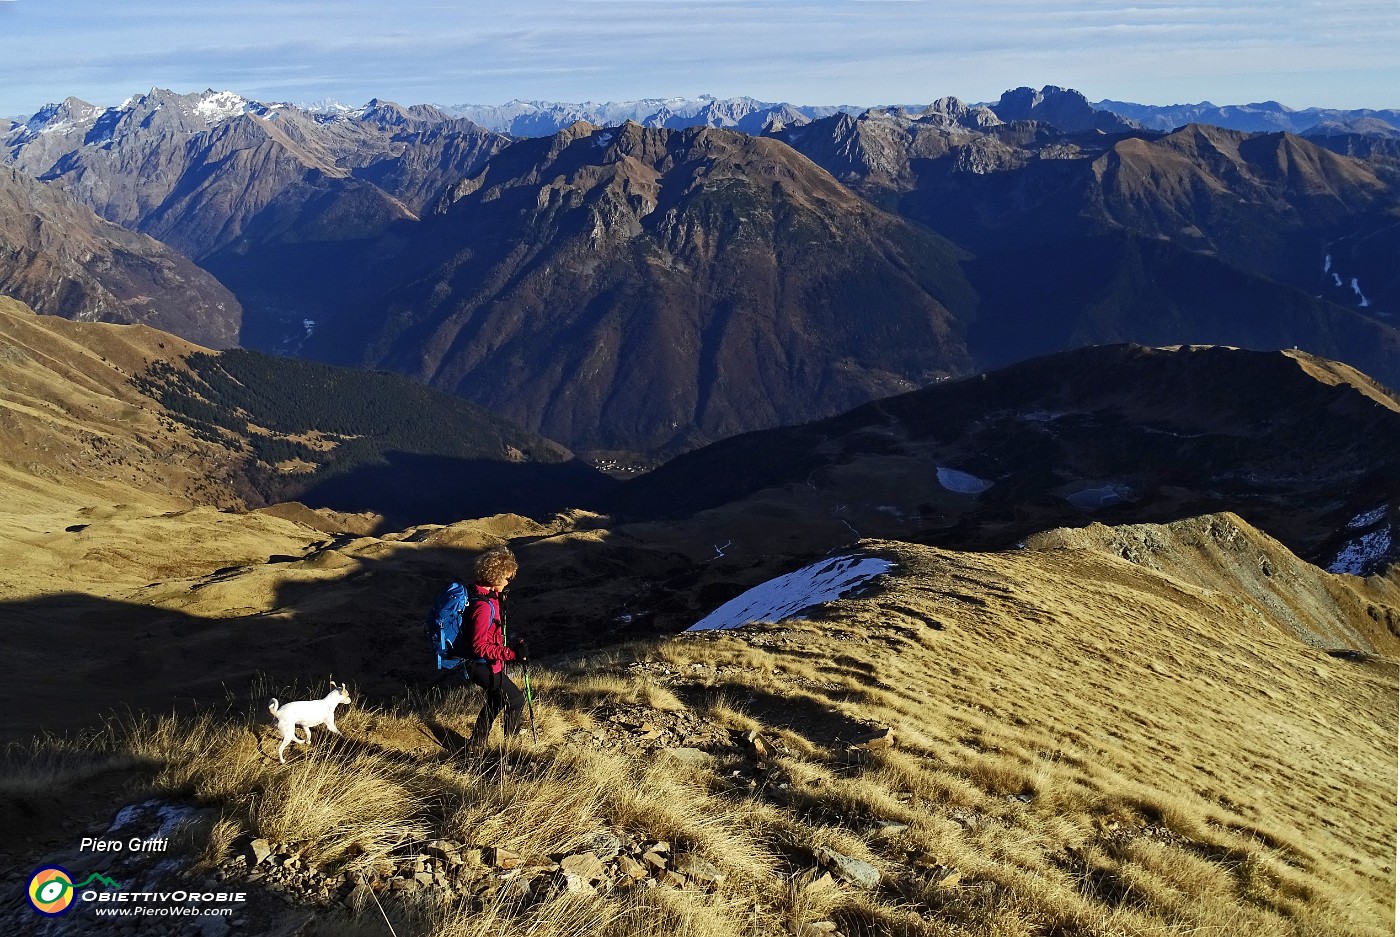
0;297;608;528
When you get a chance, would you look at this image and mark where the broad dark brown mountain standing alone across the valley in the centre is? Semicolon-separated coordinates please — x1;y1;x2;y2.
308;123;970;450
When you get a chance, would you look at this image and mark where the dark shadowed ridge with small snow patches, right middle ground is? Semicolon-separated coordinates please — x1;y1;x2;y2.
608;346;1400;559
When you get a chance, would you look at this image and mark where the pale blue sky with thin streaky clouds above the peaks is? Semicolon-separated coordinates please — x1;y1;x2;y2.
0;0;1400;116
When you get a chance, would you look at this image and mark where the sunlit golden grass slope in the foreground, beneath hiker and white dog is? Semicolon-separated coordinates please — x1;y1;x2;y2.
6;523;1397;936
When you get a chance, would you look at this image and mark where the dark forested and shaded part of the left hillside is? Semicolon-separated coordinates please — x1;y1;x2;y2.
134;350;613;529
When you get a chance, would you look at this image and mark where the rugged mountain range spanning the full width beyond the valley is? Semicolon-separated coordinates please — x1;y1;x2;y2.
0;87;1400;455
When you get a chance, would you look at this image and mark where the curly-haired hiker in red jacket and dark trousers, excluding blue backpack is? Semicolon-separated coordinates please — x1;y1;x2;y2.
454;546;529;749
